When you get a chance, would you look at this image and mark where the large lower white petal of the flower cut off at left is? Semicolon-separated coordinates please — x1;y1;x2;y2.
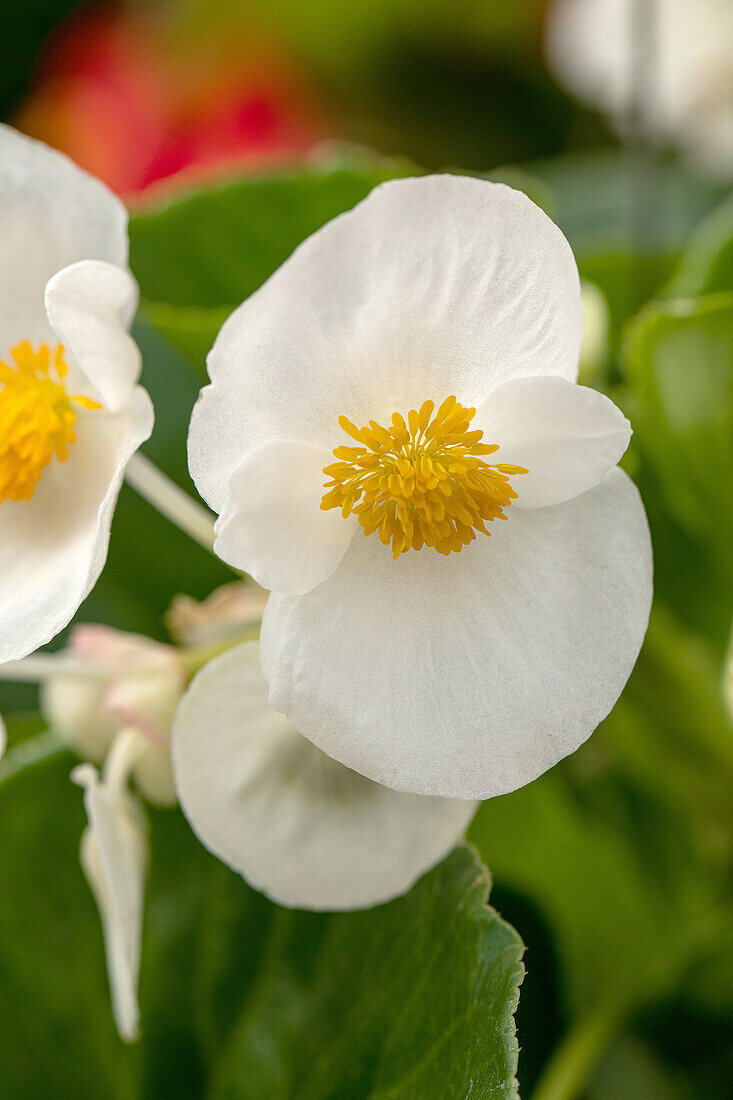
0;386;153;661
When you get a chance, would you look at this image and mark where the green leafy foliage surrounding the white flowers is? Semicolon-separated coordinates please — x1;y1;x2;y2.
0;0;733;1100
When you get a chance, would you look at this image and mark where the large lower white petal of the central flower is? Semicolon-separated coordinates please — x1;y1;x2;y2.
261;469;652;799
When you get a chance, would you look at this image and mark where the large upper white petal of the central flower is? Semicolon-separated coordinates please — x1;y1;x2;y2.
189;175;581;512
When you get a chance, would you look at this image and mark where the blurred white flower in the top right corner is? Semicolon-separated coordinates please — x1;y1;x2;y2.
547;0;733;178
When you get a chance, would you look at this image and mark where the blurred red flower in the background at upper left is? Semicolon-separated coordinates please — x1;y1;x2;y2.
14;6;328;197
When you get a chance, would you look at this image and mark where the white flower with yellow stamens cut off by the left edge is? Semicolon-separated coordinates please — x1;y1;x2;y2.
0;125;153;661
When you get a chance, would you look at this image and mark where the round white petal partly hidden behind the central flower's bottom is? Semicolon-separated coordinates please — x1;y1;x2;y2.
173;642;475;910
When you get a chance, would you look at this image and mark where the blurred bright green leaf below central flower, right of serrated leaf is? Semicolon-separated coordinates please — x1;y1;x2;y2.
469;771;669;1015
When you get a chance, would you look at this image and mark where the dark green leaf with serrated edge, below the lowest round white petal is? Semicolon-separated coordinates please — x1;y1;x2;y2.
208;848;522;1100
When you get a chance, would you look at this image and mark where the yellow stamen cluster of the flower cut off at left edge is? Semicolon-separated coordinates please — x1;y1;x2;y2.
0;340;102;504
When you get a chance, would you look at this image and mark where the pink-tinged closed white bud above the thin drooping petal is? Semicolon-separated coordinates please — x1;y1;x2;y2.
41;625;181;805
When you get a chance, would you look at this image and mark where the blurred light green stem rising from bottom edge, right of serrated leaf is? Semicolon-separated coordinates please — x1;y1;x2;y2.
532;1005;623;1100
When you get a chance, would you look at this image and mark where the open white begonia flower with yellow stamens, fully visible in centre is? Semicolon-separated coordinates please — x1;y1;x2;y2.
189;176;652;799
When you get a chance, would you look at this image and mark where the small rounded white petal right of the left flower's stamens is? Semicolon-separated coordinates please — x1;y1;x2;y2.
45;260;142;413
